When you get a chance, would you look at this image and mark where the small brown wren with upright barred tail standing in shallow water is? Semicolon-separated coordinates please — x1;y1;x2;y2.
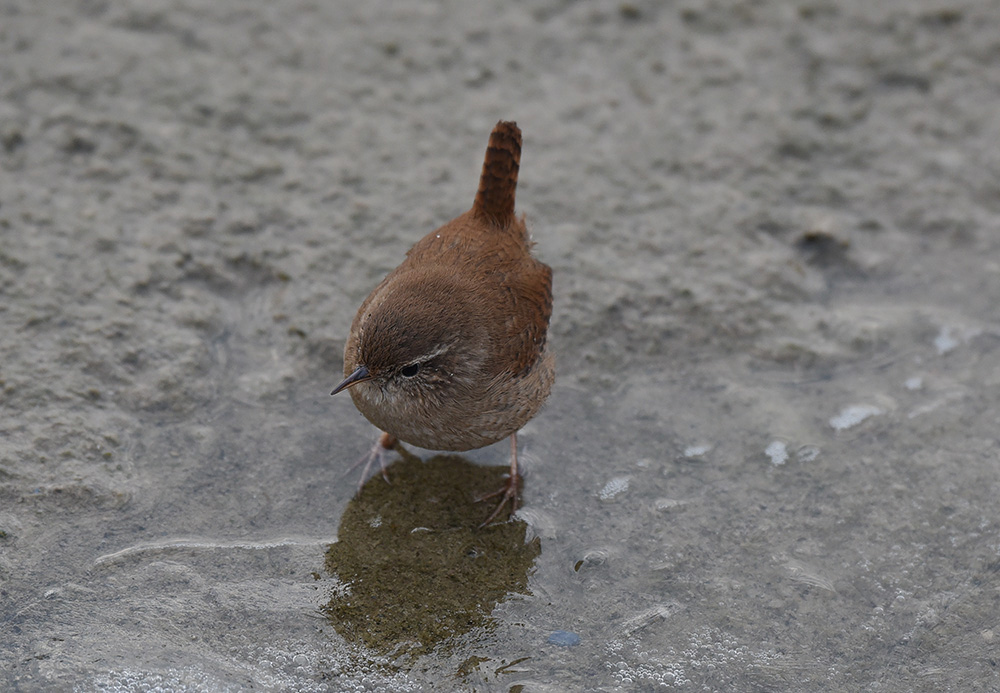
331;121;555;524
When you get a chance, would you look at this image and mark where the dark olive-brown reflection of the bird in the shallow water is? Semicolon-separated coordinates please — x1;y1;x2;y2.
324;451;540;655
